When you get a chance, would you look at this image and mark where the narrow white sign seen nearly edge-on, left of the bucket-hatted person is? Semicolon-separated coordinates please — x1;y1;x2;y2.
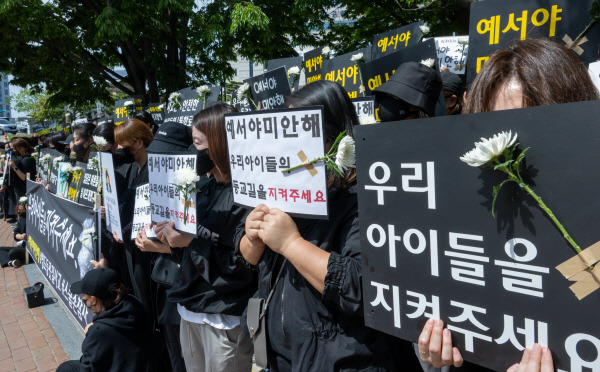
99;152;123;240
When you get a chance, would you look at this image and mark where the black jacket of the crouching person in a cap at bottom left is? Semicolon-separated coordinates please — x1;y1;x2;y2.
80;295;151;372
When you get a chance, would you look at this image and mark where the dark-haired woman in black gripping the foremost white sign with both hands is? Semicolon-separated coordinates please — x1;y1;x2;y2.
236;81;419;372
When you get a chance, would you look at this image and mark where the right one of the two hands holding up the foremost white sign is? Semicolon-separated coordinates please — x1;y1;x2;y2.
258;208;302;256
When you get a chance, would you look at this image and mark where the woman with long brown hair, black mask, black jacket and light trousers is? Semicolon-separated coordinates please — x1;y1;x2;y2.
156;103;256;372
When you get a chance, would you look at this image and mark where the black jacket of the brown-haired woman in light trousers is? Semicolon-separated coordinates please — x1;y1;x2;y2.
167;178;256;316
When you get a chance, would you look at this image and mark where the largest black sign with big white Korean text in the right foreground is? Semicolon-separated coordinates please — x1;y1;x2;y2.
355;101;600;371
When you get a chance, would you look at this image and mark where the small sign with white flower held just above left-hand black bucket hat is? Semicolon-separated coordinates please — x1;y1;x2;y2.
163;87;220;127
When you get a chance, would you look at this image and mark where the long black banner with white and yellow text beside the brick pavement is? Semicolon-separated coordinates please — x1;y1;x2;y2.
27;181;99;329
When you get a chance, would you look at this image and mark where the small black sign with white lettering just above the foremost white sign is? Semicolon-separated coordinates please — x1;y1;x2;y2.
244;66;292;110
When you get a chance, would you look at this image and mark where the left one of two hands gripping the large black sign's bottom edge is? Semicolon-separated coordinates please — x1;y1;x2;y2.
419;319;463;368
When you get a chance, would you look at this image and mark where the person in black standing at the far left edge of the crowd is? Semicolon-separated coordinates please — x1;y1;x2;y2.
0;138;36;223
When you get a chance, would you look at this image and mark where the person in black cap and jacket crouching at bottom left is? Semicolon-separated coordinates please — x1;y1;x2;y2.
57;268;152;372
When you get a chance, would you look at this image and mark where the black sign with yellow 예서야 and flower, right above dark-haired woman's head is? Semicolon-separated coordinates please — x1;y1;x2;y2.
321;47;371;98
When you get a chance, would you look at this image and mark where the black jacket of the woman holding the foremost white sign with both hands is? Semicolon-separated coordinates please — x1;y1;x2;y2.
236;187;421;372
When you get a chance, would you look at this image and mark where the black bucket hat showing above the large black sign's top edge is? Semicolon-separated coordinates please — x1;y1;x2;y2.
373;62;442;116
